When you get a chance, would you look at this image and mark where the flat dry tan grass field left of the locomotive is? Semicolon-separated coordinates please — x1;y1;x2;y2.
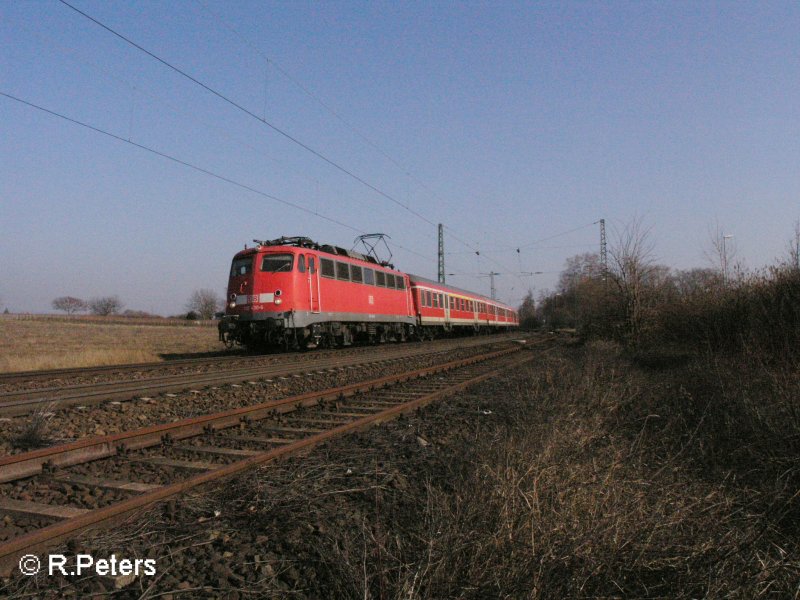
0;315;222;372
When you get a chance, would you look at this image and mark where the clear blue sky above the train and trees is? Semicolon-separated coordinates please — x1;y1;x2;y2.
0;0;800;314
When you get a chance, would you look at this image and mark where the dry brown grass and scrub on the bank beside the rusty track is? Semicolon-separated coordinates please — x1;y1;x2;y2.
0;342;800;600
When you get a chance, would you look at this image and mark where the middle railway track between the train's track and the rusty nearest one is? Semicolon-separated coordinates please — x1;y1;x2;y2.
0;336;520;417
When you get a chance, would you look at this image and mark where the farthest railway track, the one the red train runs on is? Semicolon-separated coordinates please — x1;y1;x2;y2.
0;334;514;386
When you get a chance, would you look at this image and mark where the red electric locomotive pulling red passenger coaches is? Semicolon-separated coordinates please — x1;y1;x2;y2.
219;237;519;350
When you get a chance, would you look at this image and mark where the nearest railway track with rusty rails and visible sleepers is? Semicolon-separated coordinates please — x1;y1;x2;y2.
0;346;536;576
